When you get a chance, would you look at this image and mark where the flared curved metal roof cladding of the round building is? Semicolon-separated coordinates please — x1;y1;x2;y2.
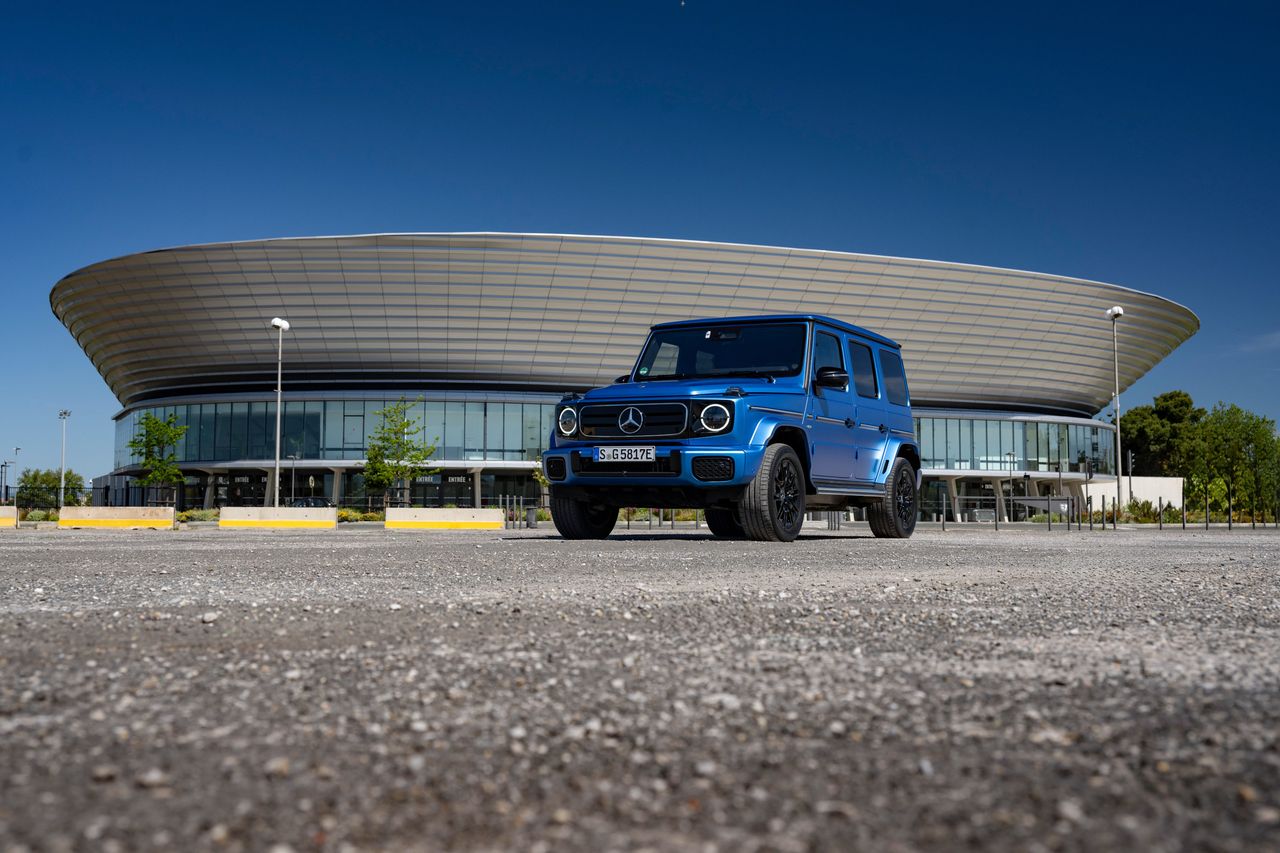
50;233;1199;415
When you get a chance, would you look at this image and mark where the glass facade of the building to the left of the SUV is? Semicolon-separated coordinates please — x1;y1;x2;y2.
115;400;556;469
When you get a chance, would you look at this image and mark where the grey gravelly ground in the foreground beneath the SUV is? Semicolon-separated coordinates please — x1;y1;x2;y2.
0;528;1280;853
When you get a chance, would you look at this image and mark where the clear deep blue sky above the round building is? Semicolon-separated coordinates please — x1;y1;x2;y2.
0;0;1280;476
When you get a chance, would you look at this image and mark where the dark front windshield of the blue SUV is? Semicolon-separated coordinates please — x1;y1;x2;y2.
636;323;805;382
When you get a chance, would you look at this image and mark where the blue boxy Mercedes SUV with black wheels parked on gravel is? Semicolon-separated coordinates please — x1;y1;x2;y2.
543;314;920;542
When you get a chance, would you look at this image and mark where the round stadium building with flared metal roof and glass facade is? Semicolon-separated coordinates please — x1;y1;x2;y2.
50;233;1199;519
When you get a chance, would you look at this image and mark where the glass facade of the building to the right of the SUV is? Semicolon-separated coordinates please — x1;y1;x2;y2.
915;416;1115;474
